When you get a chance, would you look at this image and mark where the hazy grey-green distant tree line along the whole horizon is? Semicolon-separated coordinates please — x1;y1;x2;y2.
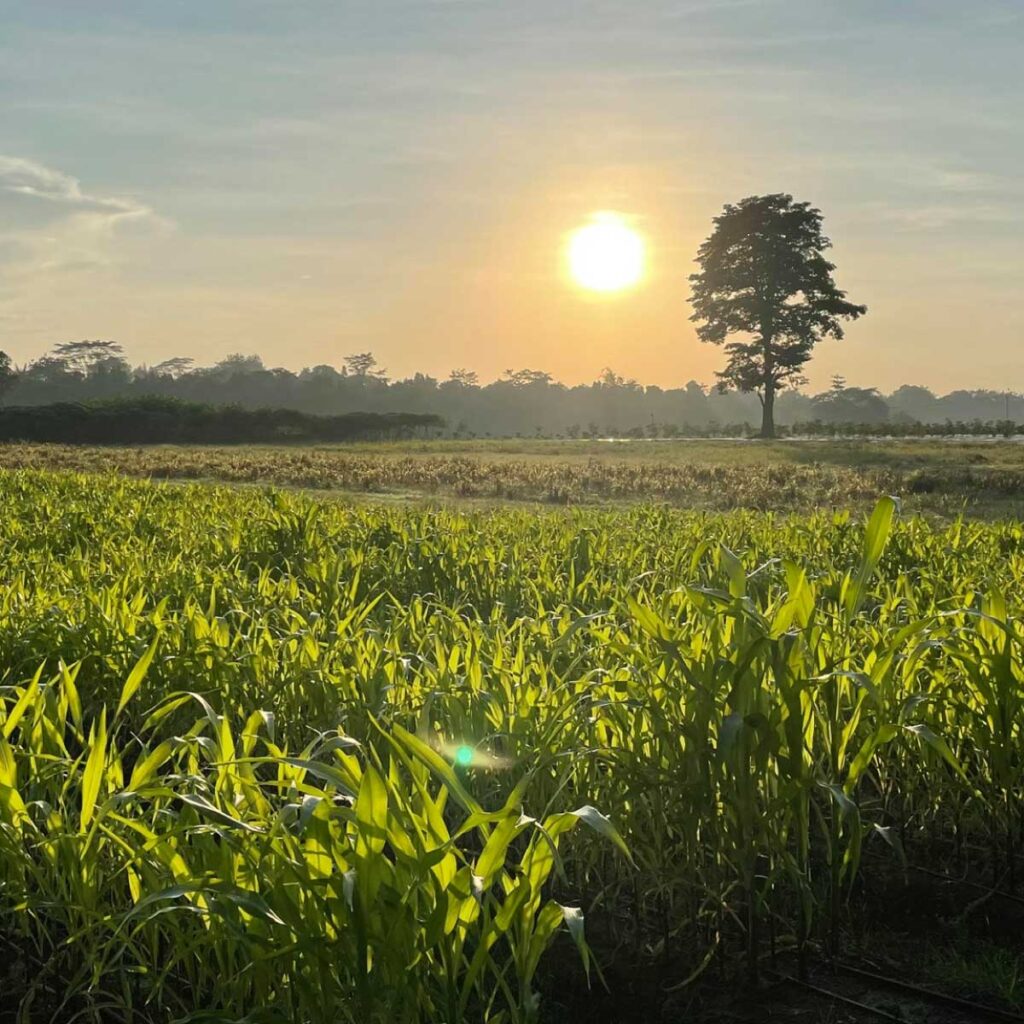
0;341;1024;437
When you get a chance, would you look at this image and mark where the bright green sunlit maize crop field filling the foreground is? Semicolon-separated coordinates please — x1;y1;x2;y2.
0;468;1024;1024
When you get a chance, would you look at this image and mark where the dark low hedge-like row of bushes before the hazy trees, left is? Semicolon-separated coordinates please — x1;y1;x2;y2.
0;395;443;444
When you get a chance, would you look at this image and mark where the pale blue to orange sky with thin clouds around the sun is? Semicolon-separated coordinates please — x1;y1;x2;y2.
0;0;1024;392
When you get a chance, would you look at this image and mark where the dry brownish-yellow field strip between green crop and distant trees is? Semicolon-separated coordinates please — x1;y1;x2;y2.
6;440;1024;517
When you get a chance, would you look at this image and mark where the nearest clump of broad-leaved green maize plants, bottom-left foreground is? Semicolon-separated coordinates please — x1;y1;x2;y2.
0;659;625;1022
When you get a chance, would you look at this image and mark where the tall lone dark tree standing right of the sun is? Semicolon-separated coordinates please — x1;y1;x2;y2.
690;194;867;437
